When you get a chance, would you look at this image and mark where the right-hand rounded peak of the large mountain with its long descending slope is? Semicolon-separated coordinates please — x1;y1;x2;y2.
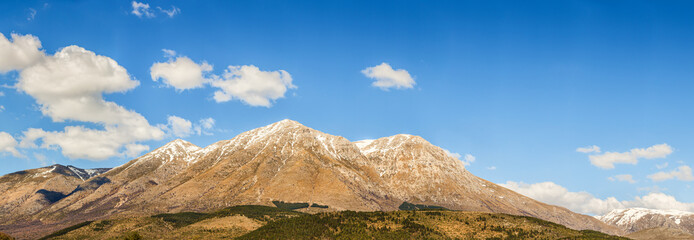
356;134;620;234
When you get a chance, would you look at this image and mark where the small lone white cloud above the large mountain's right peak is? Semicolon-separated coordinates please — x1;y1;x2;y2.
361;63;416;90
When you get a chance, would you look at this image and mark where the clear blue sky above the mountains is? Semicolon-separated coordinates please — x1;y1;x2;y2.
0;1;694;214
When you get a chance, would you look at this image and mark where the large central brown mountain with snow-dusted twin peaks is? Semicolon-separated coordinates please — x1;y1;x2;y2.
0;120;621;238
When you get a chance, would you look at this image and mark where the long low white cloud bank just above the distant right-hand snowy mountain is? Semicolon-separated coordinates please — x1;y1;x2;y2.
500;181;694;215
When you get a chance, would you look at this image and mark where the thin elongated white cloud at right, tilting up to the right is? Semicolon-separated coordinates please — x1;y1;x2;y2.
589;143;672;169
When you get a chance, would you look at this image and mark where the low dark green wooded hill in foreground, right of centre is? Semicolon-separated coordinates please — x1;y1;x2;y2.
238;210;627;239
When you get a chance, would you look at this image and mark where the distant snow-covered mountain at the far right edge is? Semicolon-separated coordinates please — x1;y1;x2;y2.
596;208;694;234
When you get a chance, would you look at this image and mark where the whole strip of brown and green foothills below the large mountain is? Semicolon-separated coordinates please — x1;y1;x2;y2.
40;205;626;239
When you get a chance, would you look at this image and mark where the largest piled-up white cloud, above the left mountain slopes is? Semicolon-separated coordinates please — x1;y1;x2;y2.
0;32;165;160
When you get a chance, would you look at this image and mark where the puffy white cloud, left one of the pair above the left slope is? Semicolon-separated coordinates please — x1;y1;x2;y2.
150;52;212;91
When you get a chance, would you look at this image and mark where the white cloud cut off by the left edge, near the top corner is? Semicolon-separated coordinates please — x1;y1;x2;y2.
0;33;44;73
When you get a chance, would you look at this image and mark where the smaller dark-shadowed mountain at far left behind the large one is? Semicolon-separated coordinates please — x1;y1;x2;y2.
0;164;109;223
